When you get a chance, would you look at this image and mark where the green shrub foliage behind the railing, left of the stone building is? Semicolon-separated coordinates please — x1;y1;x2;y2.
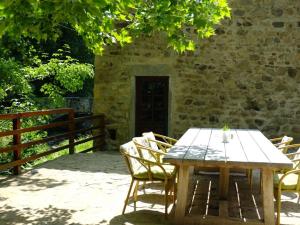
0;46;94;112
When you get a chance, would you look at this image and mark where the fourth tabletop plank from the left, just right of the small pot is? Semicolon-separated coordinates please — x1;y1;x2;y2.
225;129;248;166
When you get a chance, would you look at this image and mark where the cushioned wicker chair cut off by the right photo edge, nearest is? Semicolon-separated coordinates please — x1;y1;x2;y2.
274;147;300;225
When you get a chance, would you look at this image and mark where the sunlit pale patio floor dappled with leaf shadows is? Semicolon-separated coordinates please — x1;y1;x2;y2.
0;152;300;225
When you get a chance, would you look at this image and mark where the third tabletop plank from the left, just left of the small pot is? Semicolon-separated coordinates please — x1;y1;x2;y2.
205;129;226;166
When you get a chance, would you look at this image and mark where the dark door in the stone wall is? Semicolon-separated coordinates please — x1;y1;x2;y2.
135;77;169;136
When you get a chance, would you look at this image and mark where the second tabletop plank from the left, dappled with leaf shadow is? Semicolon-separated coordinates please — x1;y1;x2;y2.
184;129;211;163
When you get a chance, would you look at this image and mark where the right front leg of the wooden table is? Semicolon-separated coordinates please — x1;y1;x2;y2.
262;168;275;225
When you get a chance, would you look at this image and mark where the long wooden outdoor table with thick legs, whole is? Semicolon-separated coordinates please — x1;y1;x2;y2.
163;128;292;225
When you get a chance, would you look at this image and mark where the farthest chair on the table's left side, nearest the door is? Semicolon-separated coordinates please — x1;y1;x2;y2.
143;132;177;152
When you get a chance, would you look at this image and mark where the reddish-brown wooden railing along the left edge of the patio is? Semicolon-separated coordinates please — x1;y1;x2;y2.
0;108;104;175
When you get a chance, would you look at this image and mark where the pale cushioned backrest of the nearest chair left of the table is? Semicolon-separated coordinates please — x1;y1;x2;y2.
120;141;143;175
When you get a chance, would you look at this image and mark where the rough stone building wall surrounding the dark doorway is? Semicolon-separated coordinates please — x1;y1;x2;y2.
93;0;300;149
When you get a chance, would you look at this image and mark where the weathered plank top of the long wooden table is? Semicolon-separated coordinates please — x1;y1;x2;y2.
163;128;293;169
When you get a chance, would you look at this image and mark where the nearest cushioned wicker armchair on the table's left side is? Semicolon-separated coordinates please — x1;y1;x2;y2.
120;141;176;216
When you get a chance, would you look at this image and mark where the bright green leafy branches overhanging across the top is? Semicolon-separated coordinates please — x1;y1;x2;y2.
0;0;230;53
